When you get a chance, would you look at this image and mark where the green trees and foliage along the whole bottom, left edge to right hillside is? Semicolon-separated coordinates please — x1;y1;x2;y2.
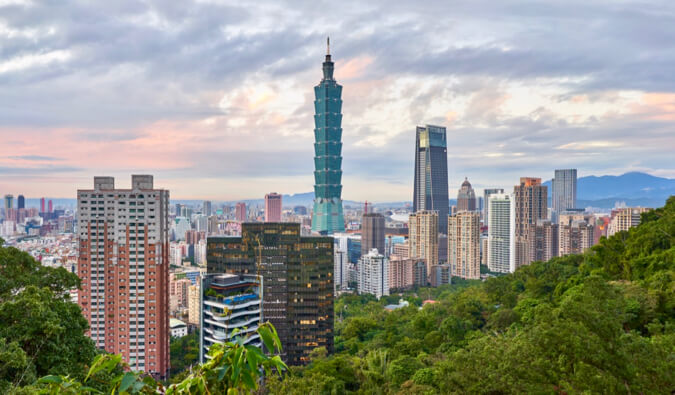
0;197;675;395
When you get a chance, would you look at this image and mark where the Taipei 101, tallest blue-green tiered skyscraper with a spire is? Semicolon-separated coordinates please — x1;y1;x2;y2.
312;39;345;235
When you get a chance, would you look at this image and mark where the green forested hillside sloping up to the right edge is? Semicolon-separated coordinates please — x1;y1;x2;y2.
267;197;675;394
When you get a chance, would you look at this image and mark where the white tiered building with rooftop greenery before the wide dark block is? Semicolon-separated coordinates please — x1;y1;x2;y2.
199;273;264;363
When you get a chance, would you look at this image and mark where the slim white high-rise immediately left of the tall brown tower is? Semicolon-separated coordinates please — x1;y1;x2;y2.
488;193;516;273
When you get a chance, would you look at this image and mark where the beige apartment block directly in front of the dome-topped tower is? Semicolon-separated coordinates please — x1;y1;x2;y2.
448;211;480;279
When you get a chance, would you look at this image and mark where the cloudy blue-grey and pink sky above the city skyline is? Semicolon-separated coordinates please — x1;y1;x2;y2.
0;0;675;202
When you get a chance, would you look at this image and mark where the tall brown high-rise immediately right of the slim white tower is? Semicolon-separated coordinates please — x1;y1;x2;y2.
513;177;548;269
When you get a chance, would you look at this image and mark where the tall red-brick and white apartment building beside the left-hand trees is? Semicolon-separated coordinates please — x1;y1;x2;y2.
77;175;169;379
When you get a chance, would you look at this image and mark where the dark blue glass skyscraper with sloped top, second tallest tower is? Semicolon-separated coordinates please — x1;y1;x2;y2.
413;125;450;234
